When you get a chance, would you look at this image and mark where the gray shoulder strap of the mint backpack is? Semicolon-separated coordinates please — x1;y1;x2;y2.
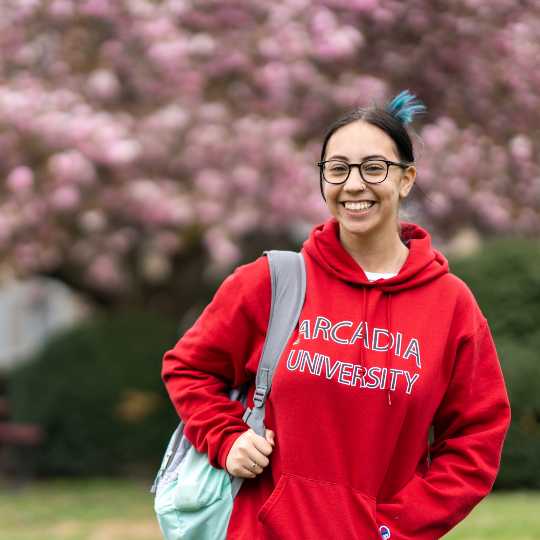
231;250;306;498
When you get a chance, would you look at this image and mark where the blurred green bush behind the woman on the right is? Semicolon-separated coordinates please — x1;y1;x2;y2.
451;238;540;489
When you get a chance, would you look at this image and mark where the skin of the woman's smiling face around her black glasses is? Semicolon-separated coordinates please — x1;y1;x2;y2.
323;120;416;243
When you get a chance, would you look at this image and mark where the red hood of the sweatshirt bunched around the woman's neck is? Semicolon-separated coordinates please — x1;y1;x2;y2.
303;217;448;293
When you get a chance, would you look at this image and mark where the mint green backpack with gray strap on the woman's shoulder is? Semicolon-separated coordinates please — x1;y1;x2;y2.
150;250;306;540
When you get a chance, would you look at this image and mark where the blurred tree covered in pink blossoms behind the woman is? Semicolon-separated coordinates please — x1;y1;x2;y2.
0;0;540;310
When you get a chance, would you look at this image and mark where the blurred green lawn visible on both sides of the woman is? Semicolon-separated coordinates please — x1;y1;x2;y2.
0;480;540;540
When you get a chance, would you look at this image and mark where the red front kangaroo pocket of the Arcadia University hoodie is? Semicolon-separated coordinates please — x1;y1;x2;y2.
257;473;380;540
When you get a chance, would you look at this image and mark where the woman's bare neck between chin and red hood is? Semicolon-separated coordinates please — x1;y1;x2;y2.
339;225;409;273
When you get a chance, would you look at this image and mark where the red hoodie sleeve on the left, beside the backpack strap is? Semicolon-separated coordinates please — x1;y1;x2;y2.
162;256;271;468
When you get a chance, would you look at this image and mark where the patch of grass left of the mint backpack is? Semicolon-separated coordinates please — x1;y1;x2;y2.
0;480;161;540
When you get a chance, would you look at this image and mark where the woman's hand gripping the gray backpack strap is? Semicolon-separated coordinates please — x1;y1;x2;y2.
225;428;275;478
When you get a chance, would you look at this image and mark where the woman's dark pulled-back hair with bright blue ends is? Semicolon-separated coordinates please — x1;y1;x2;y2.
320;90;426;201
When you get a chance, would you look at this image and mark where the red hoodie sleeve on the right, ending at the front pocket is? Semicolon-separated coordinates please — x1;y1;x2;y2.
378;318;510;540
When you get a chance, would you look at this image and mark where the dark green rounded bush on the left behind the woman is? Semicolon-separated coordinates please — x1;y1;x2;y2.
8;313;177;475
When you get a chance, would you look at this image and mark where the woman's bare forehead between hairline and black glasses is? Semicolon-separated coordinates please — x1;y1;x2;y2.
326;120;398;161
